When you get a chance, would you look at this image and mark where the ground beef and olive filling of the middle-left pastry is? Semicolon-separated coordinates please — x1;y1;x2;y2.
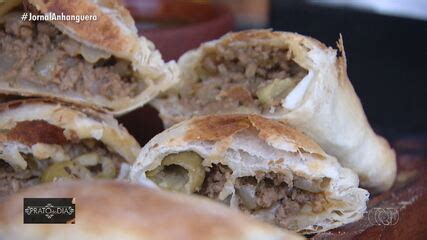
0;139;124;197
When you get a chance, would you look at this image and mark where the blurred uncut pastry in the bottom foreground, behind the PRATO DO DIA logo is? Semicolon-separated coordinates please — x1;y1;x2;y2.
0;181;299;240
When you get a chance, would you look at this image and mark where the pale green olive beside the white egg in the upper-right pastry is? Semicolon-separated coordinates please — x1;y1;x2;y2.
256;78;297;106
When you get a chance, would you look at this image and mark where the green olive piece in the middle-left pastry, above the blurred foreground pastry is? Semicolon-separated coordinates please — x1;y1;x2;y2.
41;161;77;183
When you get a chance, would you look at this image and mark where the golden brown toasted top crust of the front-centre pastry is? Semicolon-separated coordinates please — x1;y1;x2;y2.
184;114;326;156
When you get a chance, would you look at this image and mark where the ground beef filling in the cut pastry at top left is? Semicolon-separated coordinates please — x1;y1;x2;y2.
0;13;142;100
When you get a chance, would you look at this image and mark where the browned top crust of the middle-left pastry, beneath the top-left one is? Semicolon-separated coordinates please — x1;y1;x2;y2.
0;99;141;163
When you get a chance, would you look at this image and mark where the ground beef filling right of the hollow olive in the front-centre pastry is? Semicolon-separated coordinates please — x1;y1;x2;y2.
199;164;326;225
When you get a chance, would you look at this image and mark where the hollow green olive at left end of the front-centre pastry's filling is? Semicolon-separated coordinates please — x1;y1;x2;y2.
146;152;205;193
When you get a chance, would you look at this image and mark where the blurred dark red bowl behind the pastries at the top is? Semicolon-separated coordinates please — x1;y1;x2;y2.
124;0;233;60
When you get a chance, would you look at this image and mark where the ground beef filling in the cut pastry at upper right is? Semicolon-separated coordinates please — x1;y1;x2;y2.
180;45;308;114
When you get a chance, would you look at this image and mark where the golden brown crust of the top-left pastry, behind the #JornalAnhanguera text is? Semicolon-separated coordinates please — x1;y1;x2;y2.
29;0;137;53
